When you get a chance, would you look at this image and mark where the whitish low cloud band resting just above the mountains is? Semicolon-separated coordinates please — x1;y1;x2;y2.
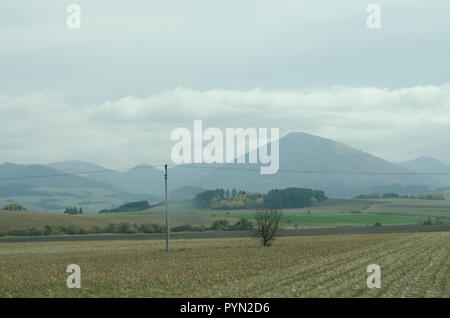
0;84;450;168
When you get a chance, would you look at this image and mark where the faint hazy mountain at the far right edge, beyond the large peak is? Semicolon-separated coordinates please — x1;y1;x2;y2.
399;157;450;186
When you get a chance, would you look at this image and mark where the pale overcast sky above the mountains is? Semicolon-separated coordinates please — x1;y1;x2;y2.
0;0;450;168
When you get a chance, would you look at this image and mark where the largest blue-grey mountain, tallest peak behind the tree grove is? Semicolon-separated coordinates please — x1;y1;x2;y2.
181;132;436;197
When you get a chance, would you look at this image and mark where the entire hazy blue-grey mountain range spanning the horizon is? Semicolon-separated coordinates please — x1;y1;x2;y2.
0;132;442;201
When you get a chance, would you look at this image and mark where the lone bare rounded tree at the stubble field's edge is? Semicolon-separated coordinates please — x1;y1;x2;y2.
255;208;281;246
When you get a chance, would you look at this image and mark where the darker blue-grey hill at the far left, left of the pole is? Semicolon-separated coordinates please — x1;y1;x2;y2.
0;163;159;213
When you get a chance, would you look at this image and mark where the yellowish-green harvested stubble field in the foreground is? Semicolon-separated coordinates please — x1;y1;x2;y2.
0;232;450;297
